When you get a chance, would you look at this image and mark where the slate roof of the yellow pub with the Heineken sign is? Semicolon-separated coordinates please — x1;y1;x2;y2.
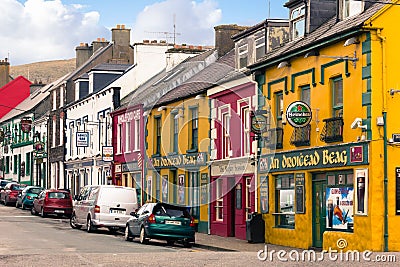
248;0;390;70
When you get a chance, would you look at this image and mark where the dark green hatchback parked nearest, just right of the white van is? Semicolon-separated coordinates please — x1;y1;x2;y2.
125;203;195;247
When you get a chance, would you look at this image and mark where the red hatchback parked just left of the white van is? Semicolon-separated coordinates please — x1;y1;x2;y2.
31;189;72;217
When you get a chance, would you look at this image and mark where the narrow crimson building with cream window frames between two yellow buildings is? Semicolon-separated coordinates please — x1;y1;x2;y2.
208;81;256;239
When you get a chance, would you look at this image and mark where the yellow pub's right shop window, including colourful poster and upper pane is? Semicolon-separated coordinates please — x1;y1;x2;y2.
325;172;354;231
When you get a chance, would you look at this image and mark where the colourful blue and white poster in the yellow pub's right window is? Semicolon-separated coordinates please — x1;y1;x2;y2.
326;187;354;229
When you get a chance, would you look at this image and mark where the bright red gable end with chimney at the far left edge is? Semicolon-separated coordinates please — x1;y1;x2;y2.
0;59;31;118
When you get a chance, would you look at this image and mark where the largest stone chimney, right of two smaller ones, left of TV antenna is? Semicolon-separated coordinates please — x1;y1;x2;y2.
111;24;133;64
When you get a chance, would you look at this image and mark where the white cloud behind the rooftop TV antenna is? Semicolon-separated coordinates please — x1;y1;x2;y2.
132;0;222;45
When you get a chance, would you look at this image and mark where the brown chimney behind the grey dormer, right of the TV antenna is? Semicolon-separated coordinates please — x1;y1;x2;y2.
214;24;247;57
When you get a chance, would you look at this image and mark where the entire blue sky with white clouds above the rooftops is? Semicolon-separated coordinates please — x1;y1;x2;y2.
4;0;288;65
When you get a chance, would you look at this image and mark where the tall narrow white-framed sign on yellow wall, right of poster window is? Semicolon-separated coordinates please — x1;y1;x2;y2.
354;169;368;215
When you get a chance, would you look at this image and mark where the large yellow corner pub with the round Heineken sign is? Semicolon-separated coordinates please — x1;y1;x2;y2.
249;0;400;251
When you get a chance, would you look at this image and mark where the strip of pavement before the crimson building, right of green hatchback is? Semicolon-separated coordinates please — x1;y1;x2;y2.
195;233;302;253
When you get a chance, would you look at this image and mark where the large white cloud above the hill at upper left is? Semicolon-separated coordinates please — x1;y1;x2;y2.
0;0;110;65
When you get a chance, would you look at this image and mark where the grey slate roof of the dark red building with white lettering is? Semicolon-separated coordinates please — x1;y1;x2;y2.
119;49;216;109
